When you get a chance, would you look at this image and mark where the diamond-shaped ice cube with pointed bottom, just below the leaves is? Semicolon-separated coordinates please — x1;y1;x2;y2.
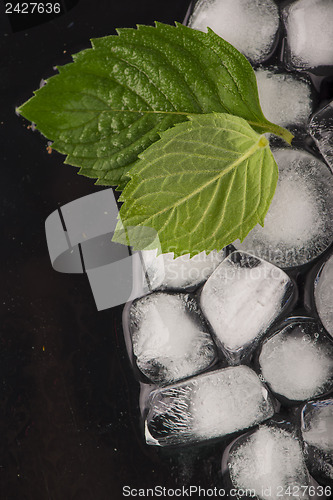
200;252;293;362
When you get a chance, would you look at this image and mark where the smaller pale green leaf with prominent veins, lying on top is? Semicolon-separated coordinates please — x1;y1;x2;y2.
114;113;278;257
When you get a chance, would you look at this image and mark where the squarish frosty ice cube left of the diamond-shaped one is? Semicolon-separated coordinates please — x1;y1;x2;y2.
124;292;216;385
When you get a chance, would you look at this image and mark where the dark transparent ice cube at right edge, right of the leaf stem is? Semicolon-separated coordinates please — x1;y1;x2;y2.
309;101;333;172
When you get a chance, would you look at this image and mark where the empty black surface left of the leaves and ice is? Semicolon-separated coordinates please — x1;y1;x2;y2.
0;0;226;500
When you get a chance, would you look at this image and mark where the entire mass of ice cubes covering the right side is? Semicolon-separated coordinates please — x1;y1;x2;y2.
123;0;333;494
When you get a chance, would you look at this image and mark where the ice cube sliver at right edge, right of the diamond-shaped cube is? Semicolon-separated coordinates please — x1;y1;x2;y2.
314;255;333;336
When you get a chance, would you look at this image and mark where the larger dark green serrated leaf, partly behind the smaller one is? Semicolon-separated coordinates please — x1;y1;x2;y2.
18;23;292;187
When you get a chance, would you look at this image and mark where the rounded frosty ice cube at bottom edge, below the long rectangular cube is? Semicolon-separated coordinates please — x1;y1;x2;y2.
228;425;310;500
